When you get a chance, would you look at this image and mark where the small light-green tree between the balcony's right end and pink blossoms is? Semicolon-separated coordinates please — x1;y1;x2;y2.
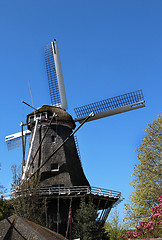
105;208;124;240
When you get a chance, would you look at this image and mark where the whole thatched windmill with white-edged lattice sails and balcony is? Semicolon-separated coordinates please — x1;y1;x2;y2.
6;40;145;236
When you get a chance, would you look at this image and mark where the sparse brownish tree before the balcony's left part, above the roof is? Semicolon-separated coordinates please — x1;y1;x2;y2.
10;165;46;226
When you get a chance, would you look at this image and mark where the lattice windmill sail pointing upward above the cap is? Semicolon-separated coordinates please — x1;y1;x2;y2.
45;40;68;109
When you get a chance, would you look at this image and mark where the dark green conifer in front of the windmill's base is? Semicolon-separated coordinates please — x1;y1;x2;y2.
72;199;108;240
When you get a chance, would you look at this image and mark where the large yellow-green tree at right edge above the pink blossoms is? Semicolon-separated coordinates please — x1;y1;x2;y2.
124;115;162;227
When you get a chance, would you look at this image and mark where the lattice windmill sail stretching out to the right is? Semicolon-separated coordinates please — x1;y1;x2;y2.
74;90;145;122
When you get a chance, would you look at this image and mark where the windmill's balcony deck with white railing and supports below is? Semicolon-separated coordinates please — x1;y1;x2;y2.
0;186;123;230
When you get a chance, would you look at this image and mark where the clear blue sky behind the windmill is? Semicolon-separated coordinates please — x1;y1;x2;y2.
0;0;162;220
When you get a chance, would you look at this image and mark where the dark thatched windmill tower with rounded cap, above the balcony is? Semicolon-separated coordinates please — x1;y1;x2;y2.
27;105;89;187
